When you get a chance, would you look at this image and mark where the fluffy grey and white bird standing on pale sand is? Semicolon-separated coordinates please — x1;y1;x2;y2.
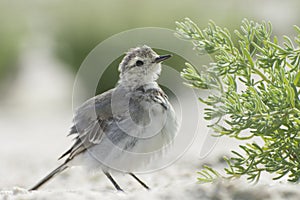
29;45;179;191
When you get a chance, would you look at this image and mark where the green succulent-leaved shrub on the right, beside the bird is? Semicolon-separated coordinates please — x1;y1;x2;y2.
176;19;300;182
